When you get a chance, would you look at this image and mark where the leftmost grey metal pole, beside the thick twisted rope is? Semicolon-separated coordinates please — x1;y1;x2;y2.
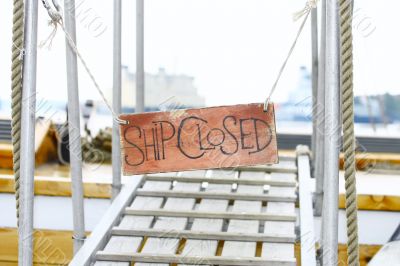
18;0;38;266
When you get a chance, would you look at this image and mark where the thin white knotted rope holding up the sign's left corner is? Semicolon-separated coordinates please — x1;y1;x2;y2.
40;0;128;125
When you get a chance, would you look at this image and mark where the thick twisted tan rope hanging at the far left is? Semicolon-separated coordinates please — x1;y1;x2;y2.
11;0;24;223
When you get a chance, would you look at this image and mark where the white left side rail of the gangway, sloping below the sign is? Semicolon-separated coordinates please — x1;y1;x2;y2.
69;176;143;266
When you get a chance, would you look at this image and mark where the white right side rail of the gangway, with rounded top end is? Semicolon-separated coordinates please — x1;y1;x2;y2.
297;146;317;265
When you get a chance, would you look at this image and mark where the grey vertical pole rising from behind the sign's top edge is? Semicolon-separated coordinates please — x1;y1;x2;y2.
136;0;144;113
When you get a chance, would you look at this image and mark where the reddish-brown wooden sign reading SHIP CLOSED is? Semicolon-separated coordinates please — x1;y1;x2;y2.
120;104;278;175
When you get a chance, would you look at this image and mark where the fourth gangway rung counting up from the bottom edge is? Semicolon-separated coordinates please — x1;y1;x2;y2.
136;189;297;202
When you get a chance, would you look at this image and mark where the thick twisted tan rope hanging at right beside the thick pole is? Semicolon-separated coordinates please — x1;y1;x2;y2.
339;0;359;266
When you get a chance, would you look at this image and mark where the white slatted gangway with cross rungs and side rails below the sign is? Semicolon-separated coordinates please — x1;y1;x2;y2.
70;146;316;266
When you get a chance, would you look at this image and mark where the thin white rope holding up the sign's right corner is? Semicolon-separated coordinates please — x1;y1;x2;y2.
264;0;318;112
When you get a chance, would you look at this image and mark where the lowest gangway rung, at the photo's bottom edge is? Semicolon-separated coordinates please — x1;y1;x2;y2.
96;251;296;266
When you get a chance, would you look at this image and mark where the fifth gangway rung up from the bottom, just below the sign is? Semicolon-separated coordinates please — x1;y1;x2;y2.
145;175;297;187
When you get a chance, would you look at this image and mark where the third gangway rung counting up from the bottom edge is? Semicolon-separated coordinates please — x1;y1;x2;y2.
125;208;296;221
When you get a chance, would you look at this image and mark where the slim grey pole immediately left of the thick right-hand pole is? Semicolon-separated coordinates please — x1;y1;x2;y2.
314;0;326;216
